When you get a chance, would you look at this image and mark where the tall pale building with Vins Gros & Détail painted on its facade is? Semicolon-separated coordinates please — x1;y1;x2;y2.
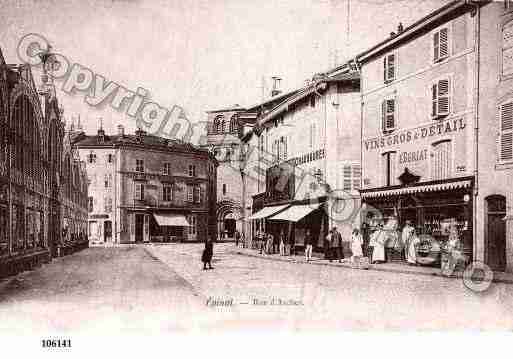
357;1;513;271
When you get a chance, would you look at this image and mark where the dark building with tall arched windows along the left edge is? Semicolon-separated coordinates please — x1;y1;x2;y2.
0;47;86;276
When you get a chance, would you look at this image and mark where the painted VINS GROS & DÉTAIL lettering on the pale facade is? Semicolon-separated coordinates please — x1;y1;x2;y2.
364;118;467;151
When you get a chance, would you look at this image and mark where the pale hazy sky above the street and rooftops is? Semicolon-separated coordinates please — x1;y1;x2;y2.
0;0;449;138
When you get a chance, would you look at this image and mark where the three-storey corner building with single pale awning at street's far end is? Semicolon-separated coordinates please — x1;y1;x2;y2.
75;126;218;243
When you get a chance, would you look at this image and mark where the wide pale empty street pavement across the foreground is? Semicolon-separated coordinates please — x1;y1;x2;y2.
0;244;513;334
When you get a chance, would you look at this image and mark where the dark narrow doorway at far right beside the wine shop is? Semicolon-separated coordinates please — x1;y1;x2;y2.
485;195;506;271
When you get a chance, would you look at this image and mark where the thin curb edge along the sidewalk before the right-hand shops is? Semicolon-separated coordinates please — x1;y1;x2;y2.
232;250;513;284
